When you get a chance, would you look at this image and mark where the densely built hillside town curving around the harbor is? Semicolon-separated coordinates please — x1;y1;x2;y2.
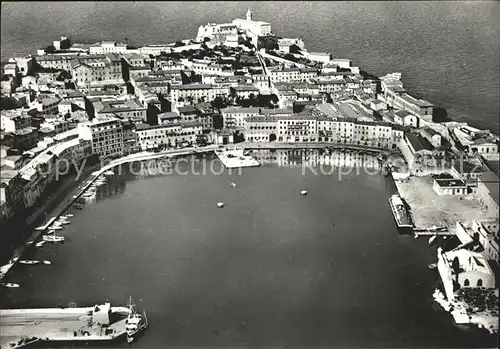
1;10;500;329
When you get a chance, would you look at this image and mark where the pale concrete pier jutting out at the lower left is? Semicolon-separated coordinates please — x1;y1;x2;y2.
0;303;130;348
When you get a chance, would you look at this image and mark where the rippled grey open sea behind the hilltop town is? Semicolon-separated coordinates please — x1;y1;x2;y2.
1;1;500;133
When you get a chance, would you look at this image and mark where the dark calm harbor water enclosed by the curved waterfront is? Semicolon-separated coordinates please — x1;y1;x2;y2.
0;150;495;348
